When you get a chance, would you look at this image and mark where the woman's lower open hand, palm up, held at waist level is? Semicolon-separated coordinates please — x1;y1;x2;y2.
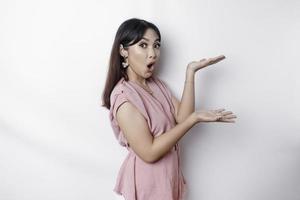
193;108;237;123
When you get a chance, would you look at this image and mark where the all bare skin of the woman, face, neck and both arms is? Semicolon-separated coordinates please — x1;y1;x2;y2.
117;29;236;163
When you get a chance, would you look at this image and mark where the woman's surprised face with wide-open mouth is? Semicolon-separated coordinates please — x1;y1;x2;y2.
121;29;160;78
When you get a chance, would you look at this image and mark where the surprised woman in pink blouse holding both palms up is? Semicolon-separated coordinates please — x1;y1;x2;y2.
103;18;236;200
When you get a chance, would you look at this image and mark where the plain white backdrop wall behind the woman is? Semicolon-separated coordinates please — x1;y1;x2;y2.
0;0;300;200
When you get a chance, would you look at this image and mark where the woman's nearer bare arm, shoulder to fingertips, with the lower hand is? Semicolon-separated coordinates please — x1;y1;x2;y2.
116;102;235;163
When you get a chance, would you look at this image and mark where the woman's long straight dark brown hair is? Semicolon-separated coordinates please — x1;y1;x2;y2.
102;18;161;109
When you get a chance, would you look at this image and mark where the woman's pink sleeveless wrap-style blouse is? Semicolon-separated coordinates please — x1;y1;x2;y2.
109;76;186;200
